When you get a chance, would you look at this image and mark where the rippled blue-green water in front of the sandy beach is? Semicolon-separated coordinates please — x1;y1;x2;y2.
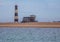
0;27;60;42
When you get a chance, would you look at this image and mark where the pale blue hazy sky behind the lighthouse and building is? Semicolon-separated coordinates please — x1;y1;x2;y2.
0;0;60;22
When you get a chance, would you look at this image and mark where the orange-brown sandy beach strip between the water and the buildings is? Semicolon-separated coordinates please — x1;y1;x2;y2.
0;22;60;28
